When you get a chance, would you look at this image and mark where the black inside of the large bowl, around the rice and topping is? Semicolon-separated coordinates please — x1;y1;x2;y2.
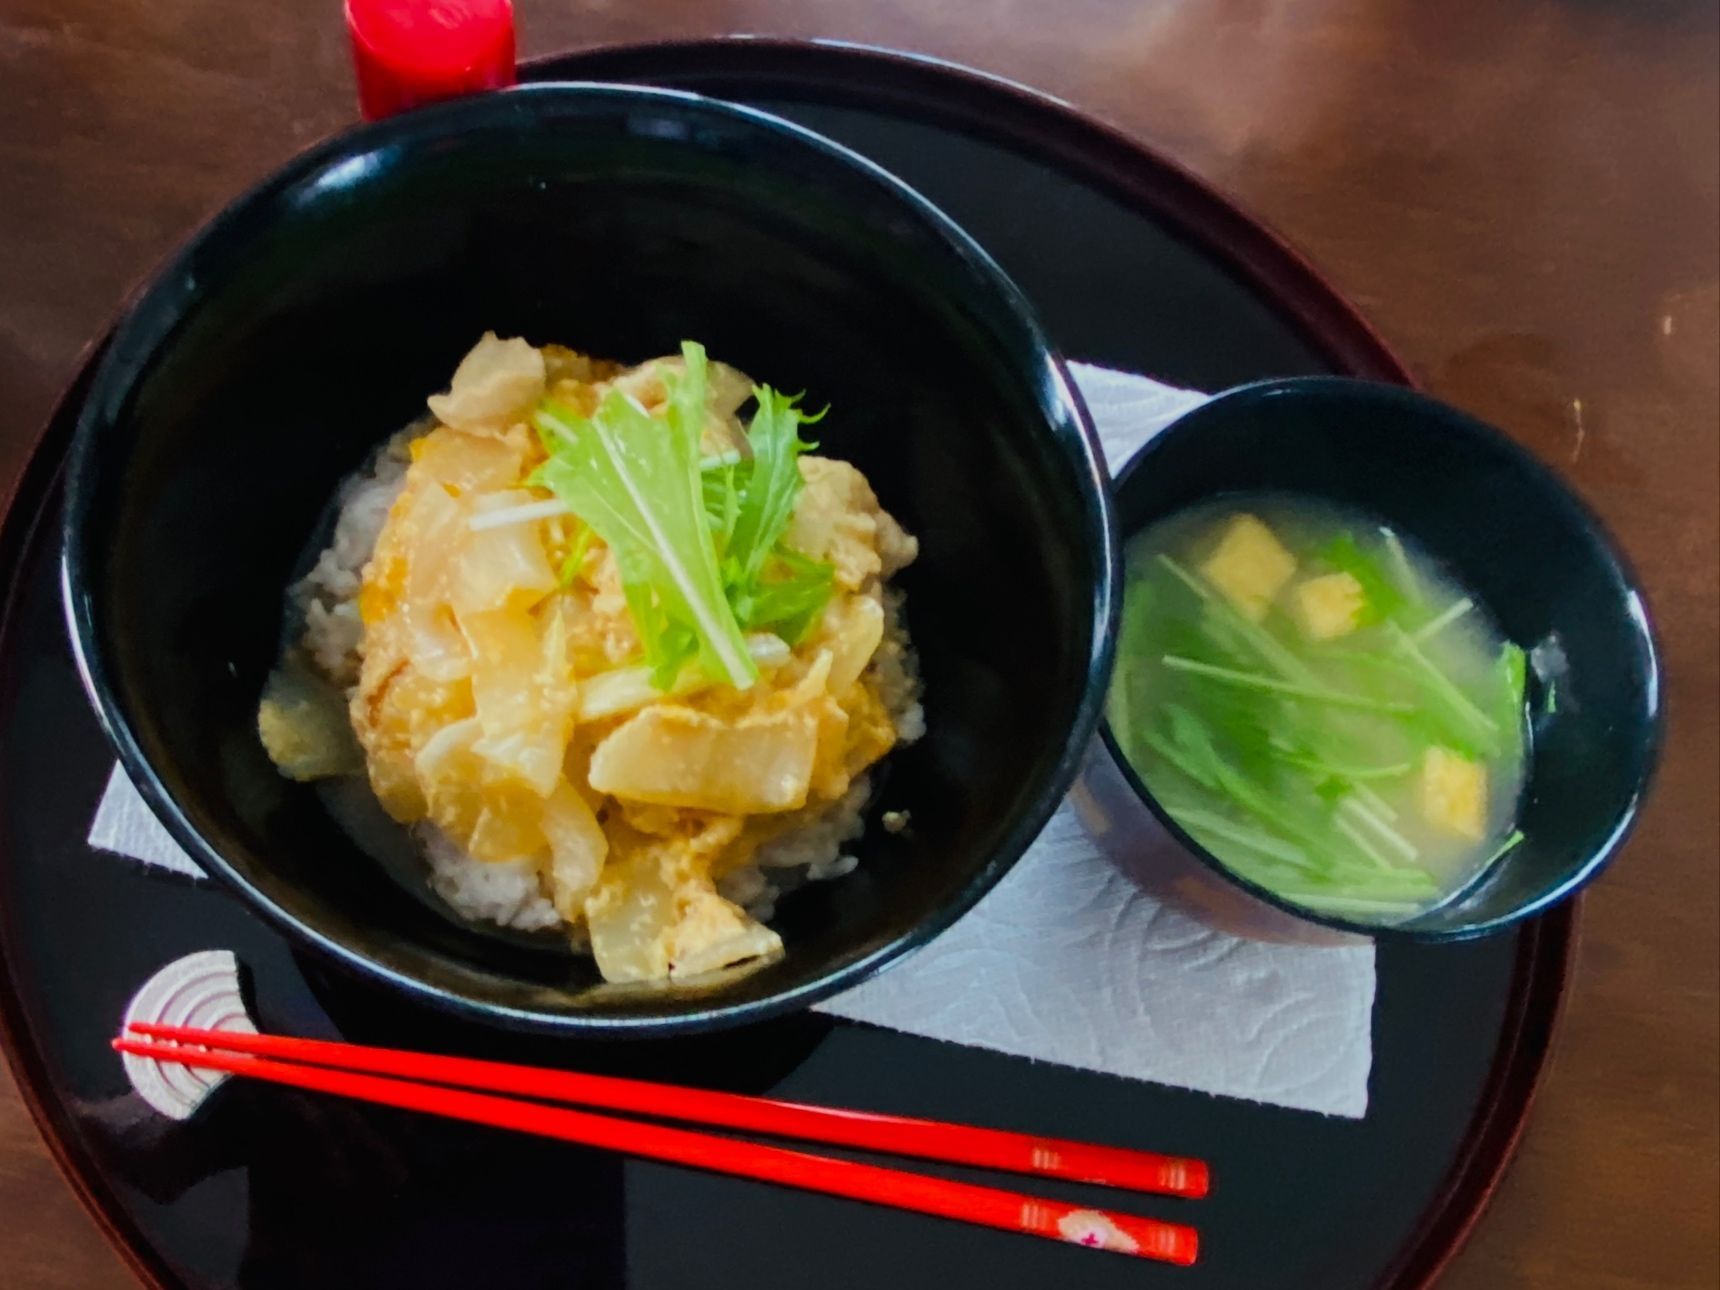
67;86;1111;1027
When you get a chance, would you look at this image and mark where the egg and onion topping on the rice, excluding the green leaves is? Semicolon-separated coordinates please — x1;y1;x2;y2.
349;335;917;980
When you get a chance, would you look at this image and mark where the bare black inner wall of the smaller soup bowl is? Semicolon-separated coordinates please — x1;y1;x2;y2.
1111;377;1660;937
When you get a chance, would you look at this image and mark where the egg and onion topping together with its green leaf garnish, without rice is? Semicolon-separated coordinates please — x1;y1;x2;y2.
260;334;917;982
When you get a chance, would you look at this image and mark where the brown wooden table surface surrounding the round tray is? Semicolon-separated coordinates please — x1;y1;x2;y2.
0;0;1720;1290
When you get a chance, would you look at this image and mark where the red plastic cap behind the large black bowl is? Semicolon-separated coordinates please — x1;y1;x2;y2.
346;0;514;120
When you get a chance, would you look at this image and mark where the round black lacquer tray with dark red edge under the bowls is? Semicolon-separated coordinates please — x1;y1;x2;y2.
0;40;1574;1290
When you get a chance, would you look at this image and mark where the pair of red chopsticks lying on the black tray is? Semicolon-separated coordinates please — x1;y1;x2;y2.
114;1022;1207;1266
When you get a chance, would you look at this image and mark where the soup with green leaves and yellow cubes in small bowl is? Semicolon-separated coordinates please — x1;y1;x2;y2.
1106;494;1529;924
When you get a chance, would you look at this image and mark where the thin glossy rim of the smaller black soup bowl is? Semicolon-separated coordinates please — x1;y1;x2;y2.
1097;375;1667;944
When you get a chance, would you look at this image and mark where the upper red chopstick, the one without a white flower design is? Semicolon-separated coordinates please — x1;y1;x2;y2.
131;1022;1209;1199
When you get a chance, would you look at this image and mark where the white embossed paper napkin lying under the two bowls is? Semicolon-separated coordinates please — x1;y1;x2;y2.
89;363;1374;1118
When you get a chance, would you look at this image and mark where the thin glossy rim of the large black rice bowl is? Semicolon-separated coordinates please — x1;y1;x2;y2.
60;81;1120;1037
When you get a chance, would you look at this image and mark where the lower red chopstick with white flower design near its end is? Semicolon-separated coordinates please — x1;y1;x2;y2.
114;1035;1199;1266
